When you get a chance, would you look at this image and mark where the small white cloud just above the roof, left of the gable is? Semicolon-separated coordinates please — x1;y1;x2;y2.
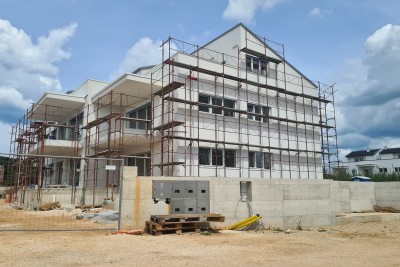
111;37;162;79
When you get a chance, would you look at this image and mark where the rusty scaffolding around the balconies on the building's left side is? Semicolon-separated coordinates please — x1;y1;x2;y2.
9;91;150;205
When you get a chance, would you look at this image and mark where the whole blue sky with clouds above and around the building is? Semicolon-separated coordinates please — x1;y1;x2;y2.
0;0;400;160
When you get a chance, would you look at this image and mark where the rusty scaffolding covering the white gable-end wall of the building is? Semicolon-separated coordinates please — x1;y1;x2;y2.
151;32;338;179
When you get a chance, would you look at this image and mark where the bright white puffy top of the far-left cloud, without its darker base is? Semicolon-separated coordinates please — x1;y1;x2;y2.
0;20;77;98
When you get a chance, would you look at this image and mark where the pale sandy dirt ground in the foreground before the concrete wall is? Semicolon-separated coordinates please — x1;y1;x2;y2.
0;221;400;267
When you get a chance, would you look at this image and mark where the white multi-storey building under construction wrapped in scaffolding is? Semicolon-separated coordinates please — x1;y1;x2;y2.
10;24;338;207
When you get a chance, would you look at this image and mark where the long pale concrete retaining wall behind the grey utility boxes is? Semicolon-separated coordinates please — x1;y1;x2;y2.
121;167;400;228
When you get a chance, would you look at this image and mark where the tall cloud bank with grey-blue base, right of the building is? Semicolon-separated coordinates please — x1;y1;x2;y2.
337;24;400;156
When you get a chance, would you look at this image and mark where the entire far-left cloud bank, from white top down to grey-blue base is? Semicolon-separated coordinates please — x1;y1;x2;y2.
0;19;78;151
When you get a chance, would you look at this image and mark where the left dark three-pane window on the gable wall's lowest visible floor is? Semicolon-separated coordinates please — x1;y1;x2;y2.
199;147;236;167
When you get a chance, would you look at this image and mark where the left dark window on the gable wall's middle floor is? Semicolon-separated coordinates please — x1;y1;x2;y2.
199;94;235;117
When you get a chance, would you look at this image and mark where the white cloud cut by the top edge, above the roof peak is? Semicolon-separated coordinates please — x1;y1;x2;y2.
222;0;284;23
